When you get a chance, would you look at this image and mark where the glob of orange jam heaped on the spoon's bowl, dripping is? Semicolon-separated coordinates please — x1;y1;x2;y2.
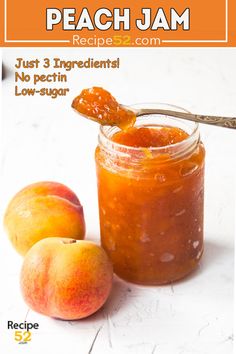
72;87;136;129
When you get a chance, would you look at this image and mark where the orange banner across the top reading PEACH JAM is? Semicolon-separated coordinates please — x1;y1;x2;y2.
0;0;236;47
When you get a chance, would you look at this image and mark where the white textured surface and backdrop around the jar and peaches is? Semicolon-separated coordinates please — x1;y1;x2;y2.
0;48;236;354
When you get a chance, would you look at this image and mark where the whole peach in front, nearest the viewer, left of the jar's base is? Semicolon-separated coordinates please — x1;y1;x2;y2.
20;237;113;320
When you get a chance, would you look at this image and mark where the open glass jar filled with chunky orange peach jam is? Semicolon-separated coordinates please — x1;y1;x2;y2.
95;105;205;285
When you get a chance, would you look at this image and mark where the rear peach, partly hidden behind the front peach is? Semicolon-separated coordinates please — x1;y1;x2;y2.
4;182;85;255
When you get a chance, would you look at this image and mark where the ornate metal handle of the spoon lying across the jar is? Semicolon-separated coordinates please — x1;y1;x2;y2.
135;108;236;129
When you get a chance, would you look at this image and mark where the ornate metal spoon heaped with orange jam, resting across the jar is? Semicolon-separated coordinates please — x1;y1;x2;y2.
72;87;236;130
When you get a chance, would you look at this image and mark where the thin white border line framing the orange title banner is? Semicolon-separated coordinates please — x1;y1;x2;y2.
4;0;228;43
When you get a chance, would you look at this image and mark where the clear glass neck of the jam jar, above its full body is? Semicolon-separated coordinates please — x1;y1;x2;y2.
98;105;200;164
